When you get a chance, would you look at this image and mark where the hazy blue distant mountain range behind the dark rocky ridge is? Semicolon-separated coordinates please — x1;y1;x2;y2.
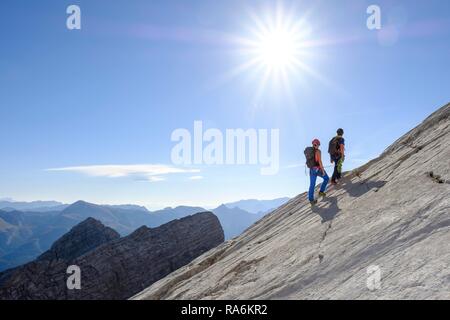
0;200;288;271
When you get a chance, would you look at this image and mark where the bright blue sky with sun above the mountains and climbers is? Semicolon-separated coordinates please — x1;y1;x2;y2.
0;0;450;208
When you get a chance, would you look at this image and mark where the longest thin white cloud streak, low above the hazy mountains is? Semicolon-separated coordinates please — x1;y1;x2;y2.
46;164;200;182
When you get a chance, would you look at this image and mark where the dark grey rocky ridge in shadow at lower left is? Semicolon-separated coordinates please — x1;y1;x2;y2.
0;212;224;300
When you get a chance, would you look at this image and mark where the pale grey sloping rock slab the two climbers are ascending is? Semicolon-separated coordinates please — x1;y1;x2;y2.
133;104;450;299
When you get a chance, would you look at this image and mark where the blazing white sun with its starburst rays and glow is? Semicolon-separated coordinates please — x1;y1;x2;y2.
218;1;334;106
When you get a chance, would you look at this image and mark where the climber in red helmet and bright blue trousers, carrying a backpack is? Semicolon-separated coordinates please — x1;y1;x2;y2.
304;139;330;205
